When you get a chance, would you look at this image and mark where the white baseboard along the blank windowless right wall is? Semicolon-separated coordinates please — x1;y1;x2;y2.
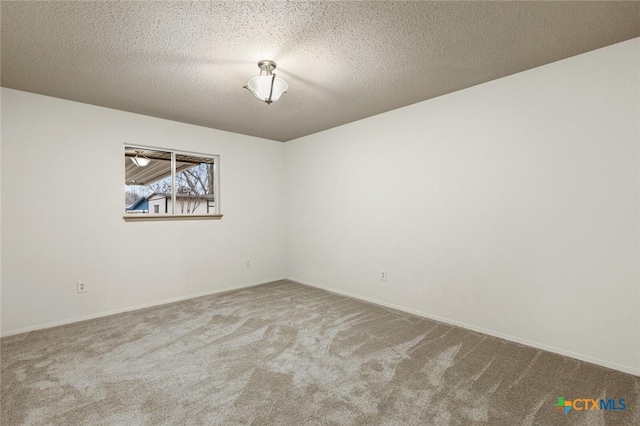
286;277;640;376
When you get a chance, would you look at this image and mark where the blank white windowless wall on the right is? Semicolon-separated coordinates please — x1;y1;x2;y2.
286;39;640;374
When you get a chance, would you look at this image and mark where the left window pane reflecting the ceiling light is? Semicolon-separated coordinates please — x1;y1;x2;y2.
124;146;172;214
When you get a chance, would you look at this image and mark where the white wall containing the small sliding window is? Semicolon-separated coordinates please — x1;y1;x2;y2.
1;88;285;335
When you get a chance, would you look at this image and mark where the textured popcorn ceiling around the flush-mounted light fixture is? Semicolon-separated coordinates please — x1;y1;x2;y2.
1;1;640;141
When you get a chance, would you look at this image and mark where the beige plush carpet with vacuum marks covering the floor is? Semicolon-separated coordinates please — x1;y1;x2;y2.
0;281;640;426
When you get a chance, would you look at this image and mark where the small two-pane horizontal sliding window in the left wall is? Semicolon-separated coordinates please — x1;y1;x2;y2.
124;146;222;220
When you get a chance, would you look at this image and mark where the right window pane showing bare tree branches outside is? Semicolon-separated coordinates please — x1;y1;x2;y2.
175;154;216;214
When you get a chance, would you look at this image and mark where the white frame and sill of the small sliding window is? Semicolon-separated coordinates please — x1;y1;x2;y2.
122;143;223;222
